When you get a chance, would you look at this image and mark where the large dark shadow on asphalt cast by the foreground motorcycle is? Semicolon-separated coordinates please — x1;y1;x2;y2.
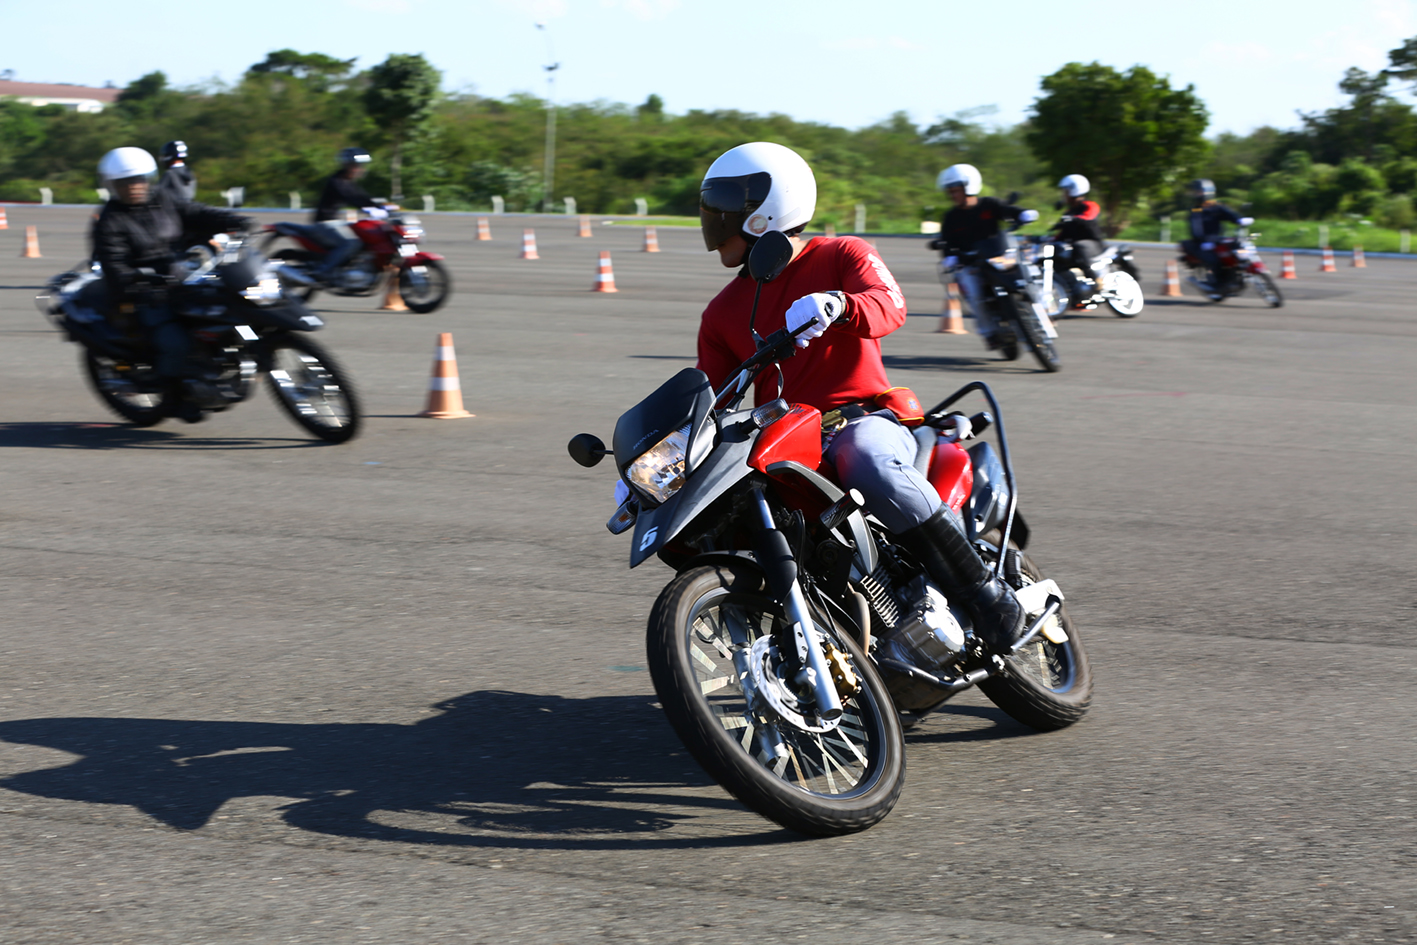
0;690;799;849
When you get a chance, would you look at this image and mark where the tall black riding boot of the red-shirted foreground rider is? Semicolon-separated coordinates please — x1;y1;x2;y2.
896;504;1024;653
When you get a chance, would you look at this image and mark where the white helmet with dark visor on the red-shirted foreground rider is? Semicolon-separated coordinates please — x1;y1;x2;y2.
699;142;816;252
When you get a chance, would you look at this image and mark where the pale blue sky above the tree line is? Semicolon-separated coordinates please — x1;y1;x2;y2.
0;0;1417;132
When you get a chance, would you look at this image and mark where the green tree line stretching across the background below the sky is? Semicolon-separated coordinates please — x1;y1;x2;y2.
0;38;1417;232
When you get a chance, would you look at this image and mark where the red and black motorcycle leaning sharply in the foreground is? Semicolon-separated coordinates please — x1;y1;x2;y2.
568;231;1093;836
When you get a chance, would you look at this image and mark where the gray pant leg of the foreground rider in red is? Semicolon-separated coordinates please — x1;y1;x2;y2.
826;414;939;534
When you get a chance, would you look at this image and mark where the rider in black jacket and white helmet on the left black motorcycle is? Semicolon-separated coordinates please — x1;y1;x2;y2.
92;147;251;419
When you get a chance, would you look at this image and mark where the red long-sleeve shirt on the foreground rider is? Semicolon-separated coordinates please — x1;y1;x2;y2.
699;237;905;411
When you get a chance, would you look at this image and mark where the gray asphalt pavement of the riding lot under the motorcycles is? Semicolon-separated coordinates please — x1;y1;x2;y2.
0;207;1417;945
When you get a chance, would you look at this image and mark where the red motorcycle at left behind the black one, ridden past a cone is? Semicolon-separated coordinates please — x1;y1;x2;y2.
262;213;452;315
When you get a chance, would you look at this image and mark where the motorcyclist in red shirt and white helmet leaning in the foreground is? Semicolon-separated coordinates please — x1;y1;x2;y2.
699;142;1023;652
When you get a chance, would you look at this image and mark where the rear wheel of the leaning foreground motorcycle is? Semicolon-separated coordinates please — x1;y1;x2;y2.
979;543;1093;731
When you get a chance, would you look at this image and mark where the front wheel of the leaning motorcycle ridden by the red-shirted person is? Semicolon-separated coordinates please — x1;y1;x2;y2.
646;565;905;836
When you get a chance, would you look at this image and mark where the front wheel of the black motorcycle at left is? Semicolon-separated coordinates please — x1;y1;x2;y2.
268;334;360;443
